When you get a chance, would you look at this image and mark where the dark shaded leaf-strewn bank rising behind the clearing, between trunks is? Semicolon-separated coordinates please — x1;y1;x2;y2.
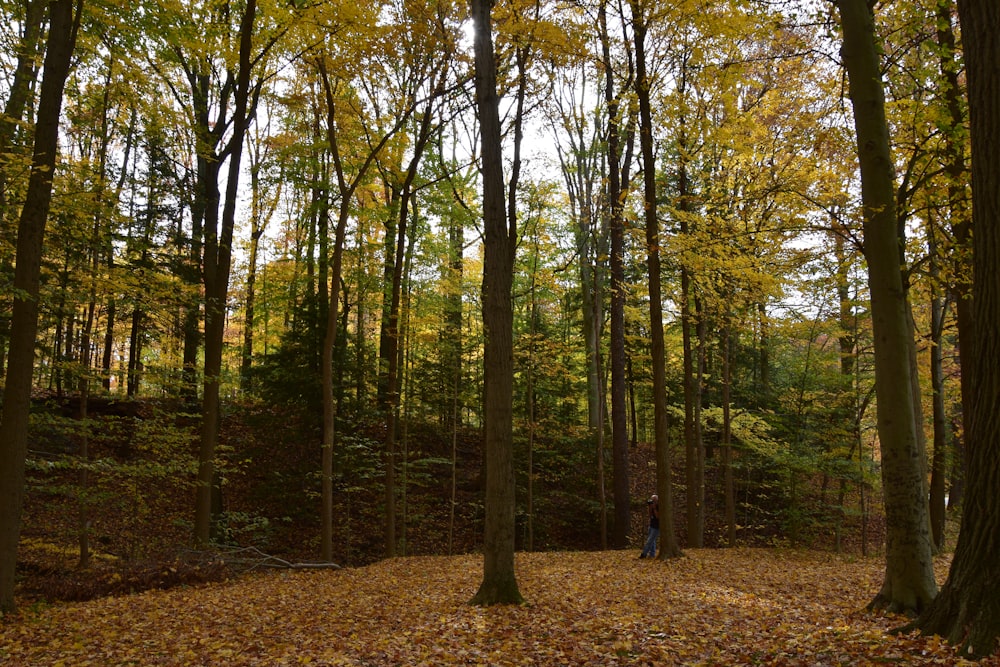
18;398;884;601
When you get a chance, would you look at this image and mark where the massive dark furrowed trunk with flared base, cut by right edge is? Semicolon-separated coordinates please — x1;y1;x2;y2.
915;0;1000;659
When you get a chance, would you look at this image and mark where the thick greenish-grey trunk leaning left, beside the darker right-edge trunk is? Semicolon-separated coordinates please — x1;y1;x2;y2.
837;0;937;614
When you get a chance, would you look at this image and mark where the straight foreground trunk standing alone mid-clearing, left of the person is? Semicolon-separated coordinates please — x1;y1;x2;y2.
471;0;523;605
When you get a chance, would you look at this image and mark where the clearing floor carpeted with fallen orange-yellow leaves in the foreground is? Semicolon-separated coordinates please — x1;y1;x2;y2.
0;549;1000;666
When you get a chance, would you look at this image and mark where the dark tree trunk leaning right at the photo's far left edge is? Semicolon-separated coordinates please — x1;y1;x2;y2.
0;0;83;612
